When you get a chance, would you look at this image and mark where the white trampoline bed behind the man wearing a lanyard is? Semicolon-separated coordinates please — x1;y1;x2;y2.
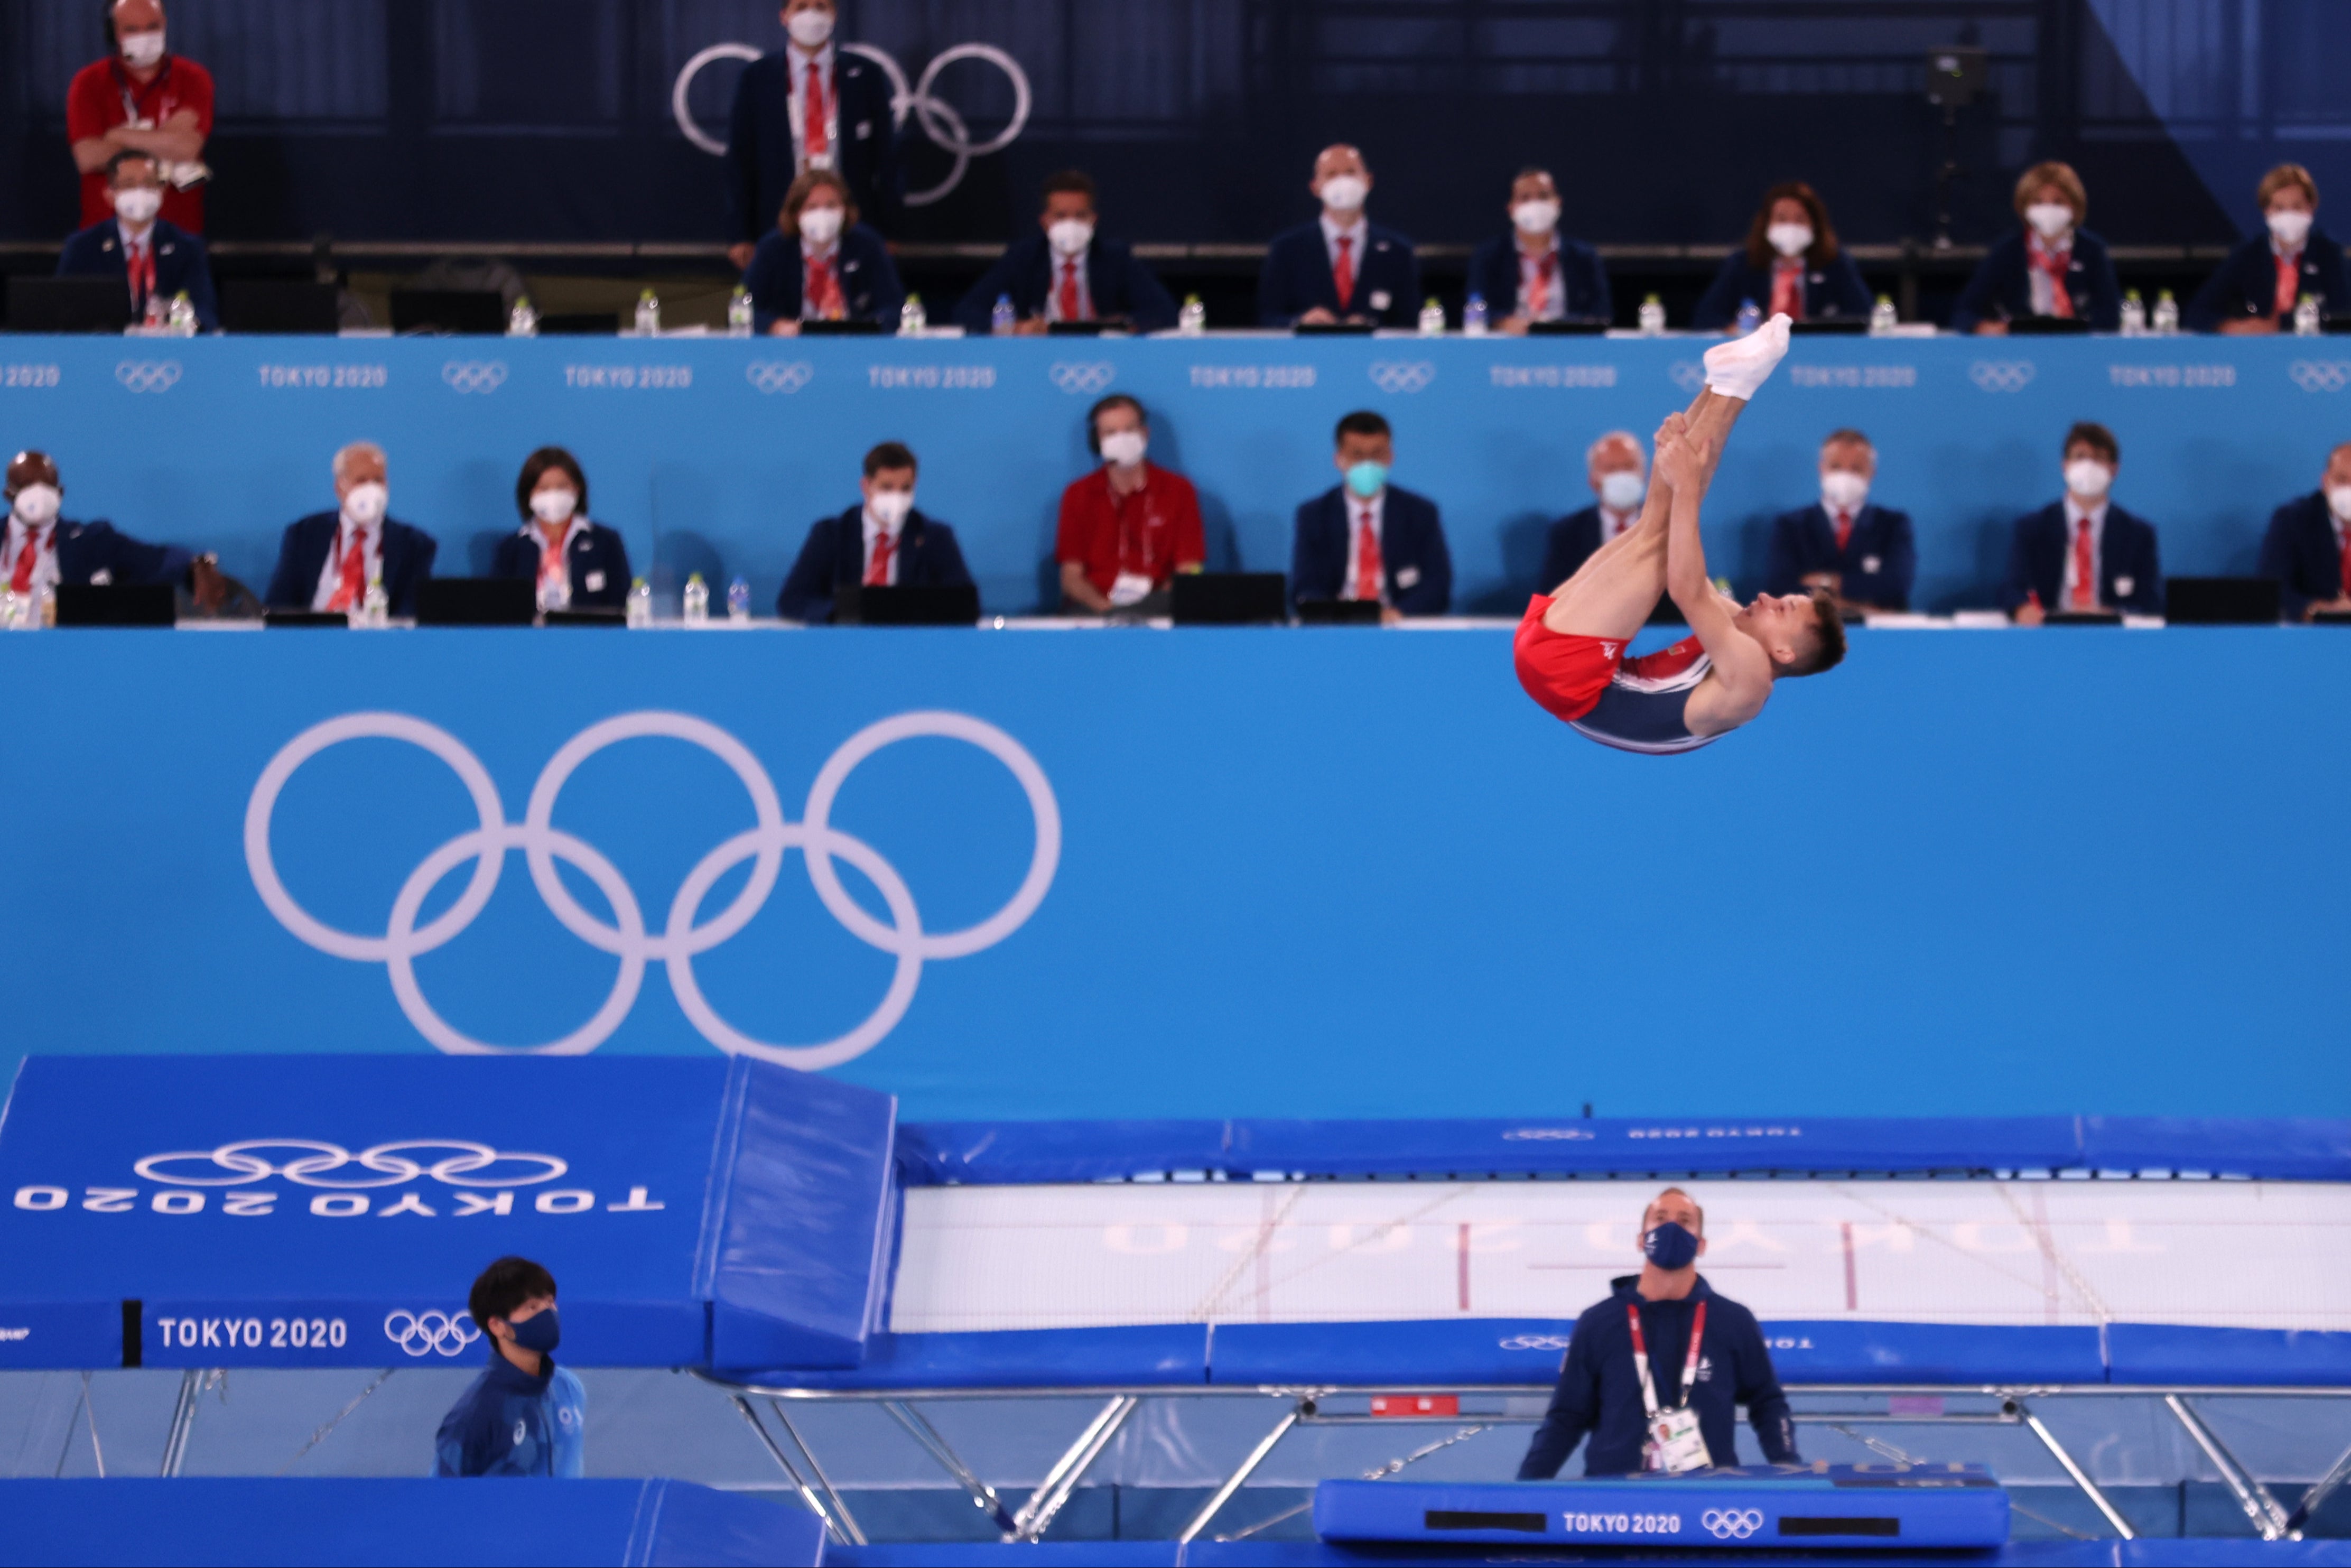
891;1180;2351;1333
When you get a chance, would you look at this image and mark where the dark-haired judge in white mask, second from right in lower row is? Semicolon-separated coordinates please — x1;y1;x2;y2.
2003;421;2163;625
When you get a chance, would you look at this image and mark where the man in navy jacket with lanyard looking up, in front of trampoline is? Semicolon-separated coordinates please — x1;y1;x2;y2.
1519;1187;1803;1481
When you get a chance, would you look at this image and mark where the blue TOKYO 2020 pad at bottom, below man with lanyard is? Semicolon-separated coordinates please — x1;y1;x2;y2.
1314;1464;2008;1552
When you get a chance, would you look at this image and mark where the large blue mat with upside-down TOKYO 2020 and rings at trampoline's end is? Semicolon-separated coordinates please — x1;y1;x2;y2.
0;1055;894;1368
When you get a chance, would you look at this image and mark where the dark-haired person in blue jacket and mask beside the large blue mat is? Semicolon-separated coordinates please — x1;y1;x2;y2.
442;1258;588;1481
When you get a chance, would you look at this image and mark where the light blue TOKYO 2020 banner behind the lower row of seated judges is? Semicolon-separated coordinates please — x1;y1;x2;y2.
0;336;2351;616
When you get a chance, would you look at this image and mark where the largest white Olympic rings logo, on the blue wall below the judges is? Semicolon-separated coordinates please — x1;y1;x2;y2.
245;712;1060;1072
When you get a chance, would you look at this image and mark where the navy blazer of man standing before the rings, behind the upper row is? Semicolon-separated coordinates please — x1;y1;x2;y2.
727;42;905;240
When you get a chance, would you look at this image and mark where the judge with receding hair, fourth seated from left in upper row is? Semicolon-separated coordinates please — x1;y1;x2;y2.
1258;143;1420;327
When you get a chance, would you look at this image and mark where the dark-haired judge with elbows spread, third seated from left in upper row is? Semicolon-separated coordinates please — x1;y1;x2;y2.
954;169;1176;334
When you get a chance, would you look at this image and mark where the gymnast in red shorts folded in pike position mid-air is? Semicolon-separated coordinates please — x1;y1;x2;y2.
1512;315;1845;752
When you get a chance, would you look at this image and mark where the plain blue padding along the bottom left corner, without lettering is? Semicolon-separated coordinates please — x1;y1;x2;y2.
0;1479;825;1568
